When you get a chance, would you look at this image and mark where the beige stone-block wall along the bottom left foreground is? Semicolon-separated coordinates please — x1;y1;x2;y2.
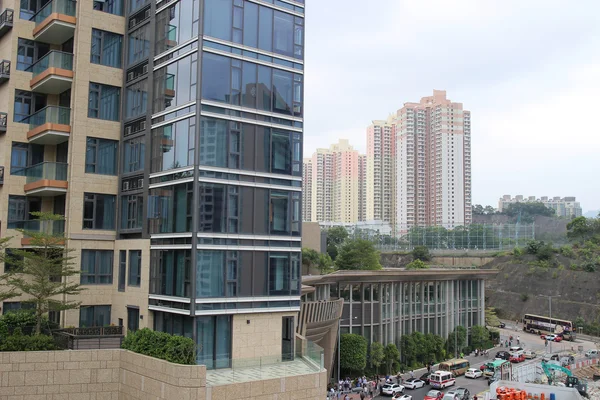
0;349;327;400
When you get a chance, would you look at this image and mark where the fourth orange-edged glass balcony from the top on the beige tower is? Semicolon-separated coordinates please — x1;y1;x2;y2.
24;161;69;196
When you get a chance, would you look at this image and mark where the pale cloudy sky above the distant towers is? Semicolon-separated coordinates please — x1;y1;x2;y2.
304;0;600;212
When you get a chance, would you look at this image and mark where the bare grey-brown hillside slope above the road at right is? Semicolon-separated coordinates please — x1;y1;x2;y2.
483;256;600;322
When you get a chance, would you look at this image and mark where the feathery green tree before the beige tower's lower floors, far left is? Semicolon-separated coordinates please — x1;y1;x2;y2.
7;212;83;334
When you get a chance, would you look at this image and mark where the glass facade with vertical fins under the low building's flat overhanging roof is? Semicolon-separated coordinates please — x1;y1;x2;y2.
322;279;485;346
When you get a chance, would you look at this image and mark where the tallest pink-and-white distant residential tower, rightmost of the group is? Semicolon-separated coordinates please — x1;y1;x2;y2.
395;90;472;231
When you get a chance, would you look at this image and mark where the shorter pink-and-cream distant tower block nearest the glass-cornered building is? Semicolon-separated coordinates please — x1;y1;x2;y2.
303;139;364;222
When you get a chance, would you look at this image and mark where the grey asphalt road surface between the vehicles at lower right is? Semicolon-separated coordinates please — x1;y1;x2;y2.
376;323;596;400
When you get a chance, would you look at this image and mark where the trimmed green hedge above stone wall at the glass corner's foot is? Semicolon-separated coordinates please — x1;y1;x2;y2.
121;328;196;365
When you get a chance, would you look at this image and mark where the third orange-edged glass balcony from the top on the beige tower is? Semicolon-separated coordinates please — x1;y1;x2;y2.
27;106;71;144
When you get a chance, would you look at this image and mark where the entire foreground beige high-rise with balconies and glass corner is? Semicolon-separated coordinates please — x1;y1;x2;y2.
0;0;308;369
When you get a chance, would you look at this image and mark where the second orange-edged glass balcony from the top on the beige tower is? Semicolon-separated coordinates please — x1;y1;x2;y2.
29;50;73;94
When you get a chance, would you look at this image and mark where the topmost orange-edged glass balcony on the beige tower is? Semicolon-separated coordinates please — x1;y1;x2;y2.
31;0;77;44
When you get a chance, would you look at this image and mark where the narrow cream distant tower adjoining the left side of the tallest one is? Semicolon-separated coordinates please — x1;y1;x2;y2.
366;115;396;224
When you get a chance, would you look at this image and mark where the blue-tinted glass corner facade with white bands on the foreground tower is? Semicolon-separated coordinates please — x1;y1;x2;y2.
117;0;304;368
